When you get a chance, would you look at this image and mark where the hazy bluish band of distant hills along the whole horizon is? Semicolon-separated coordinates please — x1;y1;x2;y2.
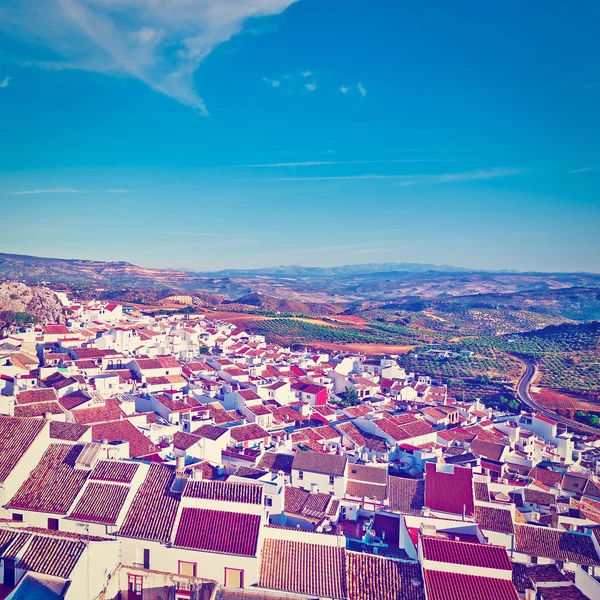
0;254;600;305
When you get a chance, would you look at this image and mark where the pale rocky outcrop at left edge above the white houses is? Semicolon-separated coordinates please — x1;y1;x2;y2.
0;281;64;323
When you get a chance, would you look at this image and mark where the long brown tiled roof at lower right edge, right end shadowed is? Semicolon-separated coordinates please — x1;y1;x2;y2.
515;525;600;566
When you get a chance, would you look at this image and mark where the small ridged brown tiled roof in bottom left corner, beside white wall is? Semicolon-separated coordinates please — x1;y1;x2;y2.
19;535;85;579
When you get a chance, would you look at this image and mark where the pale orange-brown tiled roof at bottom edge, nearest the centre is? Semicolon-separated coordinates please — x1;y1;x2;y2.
259;539;346;598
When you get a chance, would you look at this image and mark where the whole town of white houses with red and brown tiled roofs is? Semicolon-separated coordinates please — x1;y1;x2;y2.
0;293;600;600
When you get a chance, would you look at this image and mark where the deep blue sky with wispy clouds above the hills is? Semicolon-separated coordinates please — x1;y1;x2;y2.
0;0;600;272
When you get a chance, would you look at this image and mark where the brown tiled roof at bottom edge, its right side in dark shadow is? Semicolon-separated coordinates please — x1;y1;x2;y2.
346;552;425;600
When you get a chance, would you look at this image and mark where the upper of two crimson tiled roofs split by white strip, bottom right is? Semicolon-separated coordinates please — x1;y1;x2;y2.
421;536;512;571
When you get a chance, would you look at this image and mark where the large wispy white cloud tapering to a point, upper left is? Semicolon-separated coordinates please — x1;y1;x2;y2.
0;0;297;114
